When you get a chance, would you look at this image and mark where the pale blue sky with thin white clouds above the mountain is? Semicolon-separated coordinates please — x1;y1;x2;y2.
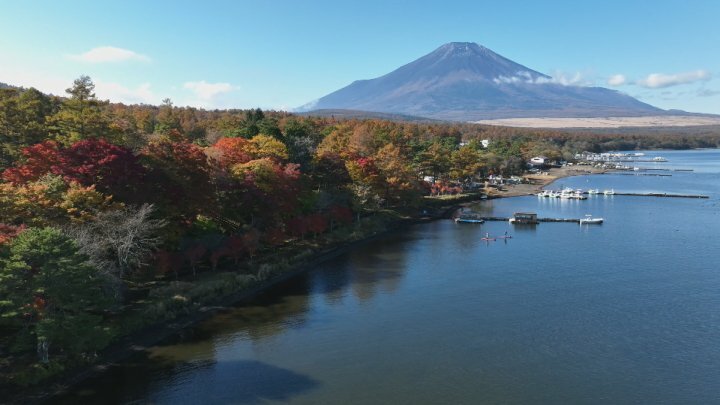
0;0;720;114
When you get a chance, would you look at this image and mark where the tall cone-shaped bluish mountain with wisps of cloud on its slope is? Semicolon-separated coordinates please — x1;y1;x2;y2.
299;42;678;121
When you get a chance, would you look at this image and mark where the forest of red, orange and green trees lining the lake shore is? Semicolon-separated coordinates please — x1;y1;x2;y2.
0;76;720;384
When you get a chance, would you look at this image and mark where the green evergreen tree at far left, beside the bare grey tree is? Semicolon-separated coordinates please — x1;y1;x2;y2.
0;228;111;362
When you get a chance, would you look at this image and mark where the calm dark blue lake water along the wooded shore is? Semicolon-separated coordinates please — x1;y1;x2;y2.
56;150;720;404
